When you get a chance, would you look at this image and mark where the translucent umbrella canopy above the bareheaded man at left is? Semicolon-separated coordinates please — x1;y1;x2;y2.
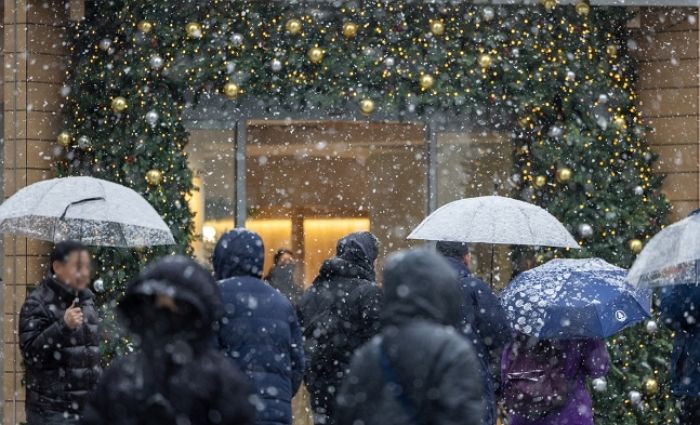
0;177;175;247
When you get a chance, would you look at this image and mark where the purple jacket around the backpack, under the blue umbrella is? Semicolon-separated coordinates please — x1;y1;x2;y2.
501;340;609;425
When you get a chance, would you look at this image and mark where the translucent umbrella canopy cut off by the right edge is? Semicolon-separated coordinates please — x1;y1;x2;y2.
627;211;700;286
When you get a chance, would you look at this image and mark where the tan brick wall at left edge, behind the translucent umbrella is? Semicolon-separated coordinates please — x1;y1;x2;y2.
2;0;68;424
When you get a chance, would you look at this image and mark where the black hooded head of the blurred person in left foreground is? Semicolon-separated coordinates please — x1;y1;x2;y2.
118;256;223;345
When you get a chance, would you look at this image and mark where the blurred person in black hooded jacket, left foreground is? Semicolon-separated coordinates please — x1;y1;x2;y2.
81;256;255;425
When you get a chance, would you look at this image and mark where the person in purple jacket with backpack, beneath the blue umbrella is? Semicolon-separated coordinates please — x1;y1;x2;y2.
501;335;609;425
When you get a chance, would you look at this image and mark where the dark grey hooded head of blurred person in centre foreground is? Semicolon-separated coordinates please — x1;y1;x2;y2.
382;249;462;326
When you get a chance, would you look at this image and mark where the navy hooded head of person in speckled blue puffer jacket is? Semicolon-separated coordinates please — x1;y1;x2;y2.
212;228;265;279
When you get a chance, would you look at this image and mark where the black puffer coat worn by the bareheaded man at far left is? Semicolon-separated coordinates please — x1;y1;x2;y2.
19;277;101;413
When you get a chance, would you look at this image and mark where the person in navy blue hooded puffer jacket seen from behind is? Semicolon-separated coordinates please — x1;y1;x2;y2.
213;229;304;425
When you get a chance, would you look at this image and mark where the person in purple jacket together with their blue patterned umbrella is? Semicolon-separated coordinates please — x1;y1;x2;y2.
501;258;651;425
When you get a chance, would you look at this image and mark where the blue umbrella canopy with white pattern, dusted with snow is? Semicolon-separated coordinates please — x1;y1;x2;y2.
501;258;651;339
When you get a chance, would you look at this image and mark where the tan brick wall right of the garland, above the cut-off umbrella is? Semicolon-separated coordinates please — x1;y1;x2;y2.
633;8;700;220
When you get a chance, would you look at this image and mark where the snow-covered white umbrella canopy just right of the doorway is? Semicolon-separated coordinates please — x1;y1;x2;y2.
408;196;579;249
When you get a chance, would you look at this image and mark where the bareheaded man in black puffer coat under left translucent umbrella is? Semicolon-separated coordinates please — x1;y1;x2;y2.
19;242;101;425
